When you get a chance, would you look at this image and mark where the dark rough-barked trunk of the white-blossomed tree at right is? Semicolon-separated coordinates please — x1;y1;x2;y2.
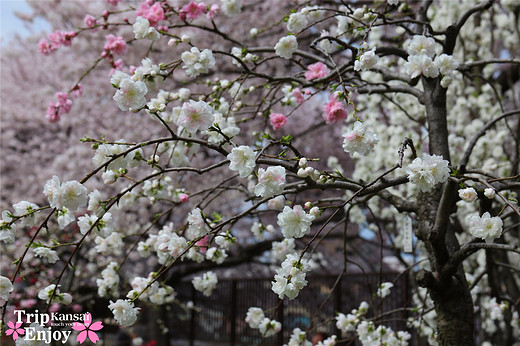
418;78;475;346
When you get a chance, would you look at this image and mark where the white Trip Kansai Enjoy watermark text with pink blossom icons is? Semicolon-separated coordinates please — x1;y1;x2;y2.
5;310;103;344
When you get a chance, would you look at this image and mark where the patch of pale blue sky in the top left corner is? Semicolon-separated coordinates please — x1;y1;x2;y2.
0;0;50;44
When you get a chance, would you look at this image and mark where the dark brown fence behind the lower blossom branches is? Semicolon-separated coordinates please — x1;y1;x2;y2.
169;274;408;345
